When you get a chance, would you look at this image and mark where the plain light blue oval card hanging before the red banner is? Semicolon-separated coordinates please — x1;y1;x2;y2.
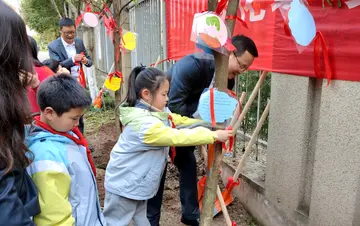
288;0;316;46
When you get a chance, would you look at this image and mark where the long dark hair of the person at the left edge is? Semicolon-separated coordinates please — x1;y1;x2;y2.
0;1;33;173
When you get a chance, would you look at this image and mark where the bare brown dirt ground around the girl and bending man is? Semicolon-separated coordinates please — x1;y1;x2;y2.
85;112;258;226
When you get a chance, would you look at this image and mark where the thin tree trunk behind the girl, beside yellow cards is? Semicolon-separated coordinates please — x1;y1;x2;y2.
113;0;122;134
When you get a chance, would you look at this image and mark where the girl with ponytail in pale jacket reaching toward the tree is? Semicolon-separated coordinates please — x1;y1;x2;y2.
104;67;232;226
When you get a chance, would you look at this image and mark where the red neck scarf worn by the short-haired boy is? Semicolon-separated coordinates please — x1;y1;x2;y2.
34;116;96;176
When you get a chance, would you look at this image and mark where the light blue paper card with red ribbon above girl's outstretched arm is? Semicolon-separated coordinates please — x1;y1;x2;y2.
198;89;238;123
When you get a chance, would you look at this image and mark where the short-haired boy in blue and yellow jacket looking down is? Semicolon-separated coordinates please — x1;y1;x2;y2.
25;74;105;226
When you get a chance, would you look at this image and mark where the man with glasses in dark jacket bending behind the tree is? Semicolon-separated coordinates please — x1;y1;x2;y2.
147;35;258;226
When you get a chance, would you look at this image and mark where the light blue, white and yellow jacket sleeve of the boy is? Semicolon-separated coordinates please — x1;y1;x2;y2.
28;145;75;226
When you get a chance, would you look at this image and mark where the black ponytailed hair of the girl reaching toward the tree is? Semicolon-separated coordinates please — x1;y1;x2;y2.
125;66;167;107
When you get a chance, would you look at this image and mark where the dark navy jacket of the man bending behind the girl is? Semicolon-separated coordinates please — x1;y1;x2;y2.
168;53;235;117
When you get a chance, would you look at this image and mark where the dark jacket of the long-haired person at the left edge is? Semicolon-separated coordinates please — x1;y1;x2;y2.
0;169;40;226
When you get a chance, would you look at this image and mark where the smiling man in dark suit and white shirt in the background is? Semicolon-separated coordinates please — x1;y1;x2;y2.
48;18;92;133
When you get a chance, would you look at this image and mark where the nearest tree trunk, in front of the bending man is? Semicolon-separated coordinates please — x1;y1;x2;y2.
200;0;239;226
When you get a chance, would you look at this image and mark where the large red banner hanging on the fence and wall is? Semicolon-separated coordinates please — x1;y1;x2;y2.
166;0;360;81
